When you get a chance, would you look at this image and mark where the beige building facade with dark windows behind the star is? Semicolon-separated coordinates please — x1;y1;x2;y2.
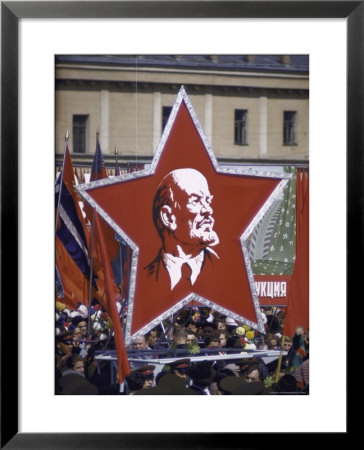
55;55;309;165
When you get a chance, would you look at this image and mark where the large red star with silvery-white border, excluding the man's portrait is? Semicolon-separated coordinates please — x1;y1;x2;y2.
78;87;288;343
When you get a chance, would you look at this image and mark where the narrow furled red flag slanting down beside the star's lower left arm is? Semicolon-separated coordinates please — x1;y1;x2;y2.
95;211;130;384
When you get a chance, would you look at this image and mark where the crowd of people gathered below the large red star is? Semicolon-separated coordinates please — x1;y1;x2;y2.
55;302;309;395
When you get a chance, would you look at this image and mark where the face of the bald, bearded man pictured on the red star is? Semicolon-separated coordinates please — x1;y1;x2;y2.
168;169;219;251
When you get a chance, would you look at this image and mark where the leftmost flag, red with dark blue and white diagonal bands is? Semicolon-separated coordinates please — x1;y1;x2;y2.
55;146;90;309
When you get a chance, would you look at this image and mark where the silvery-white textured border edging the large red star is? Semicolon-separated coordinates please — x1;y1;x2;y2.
76;86;292;345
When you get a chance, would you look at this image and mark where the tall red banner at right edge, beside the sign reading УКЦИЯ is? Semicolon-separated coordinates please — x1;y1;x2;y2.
283;169;309;336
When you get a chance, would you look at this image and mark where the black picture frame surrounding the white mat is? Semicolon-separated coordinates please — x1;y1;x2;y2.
0;0;356;449
